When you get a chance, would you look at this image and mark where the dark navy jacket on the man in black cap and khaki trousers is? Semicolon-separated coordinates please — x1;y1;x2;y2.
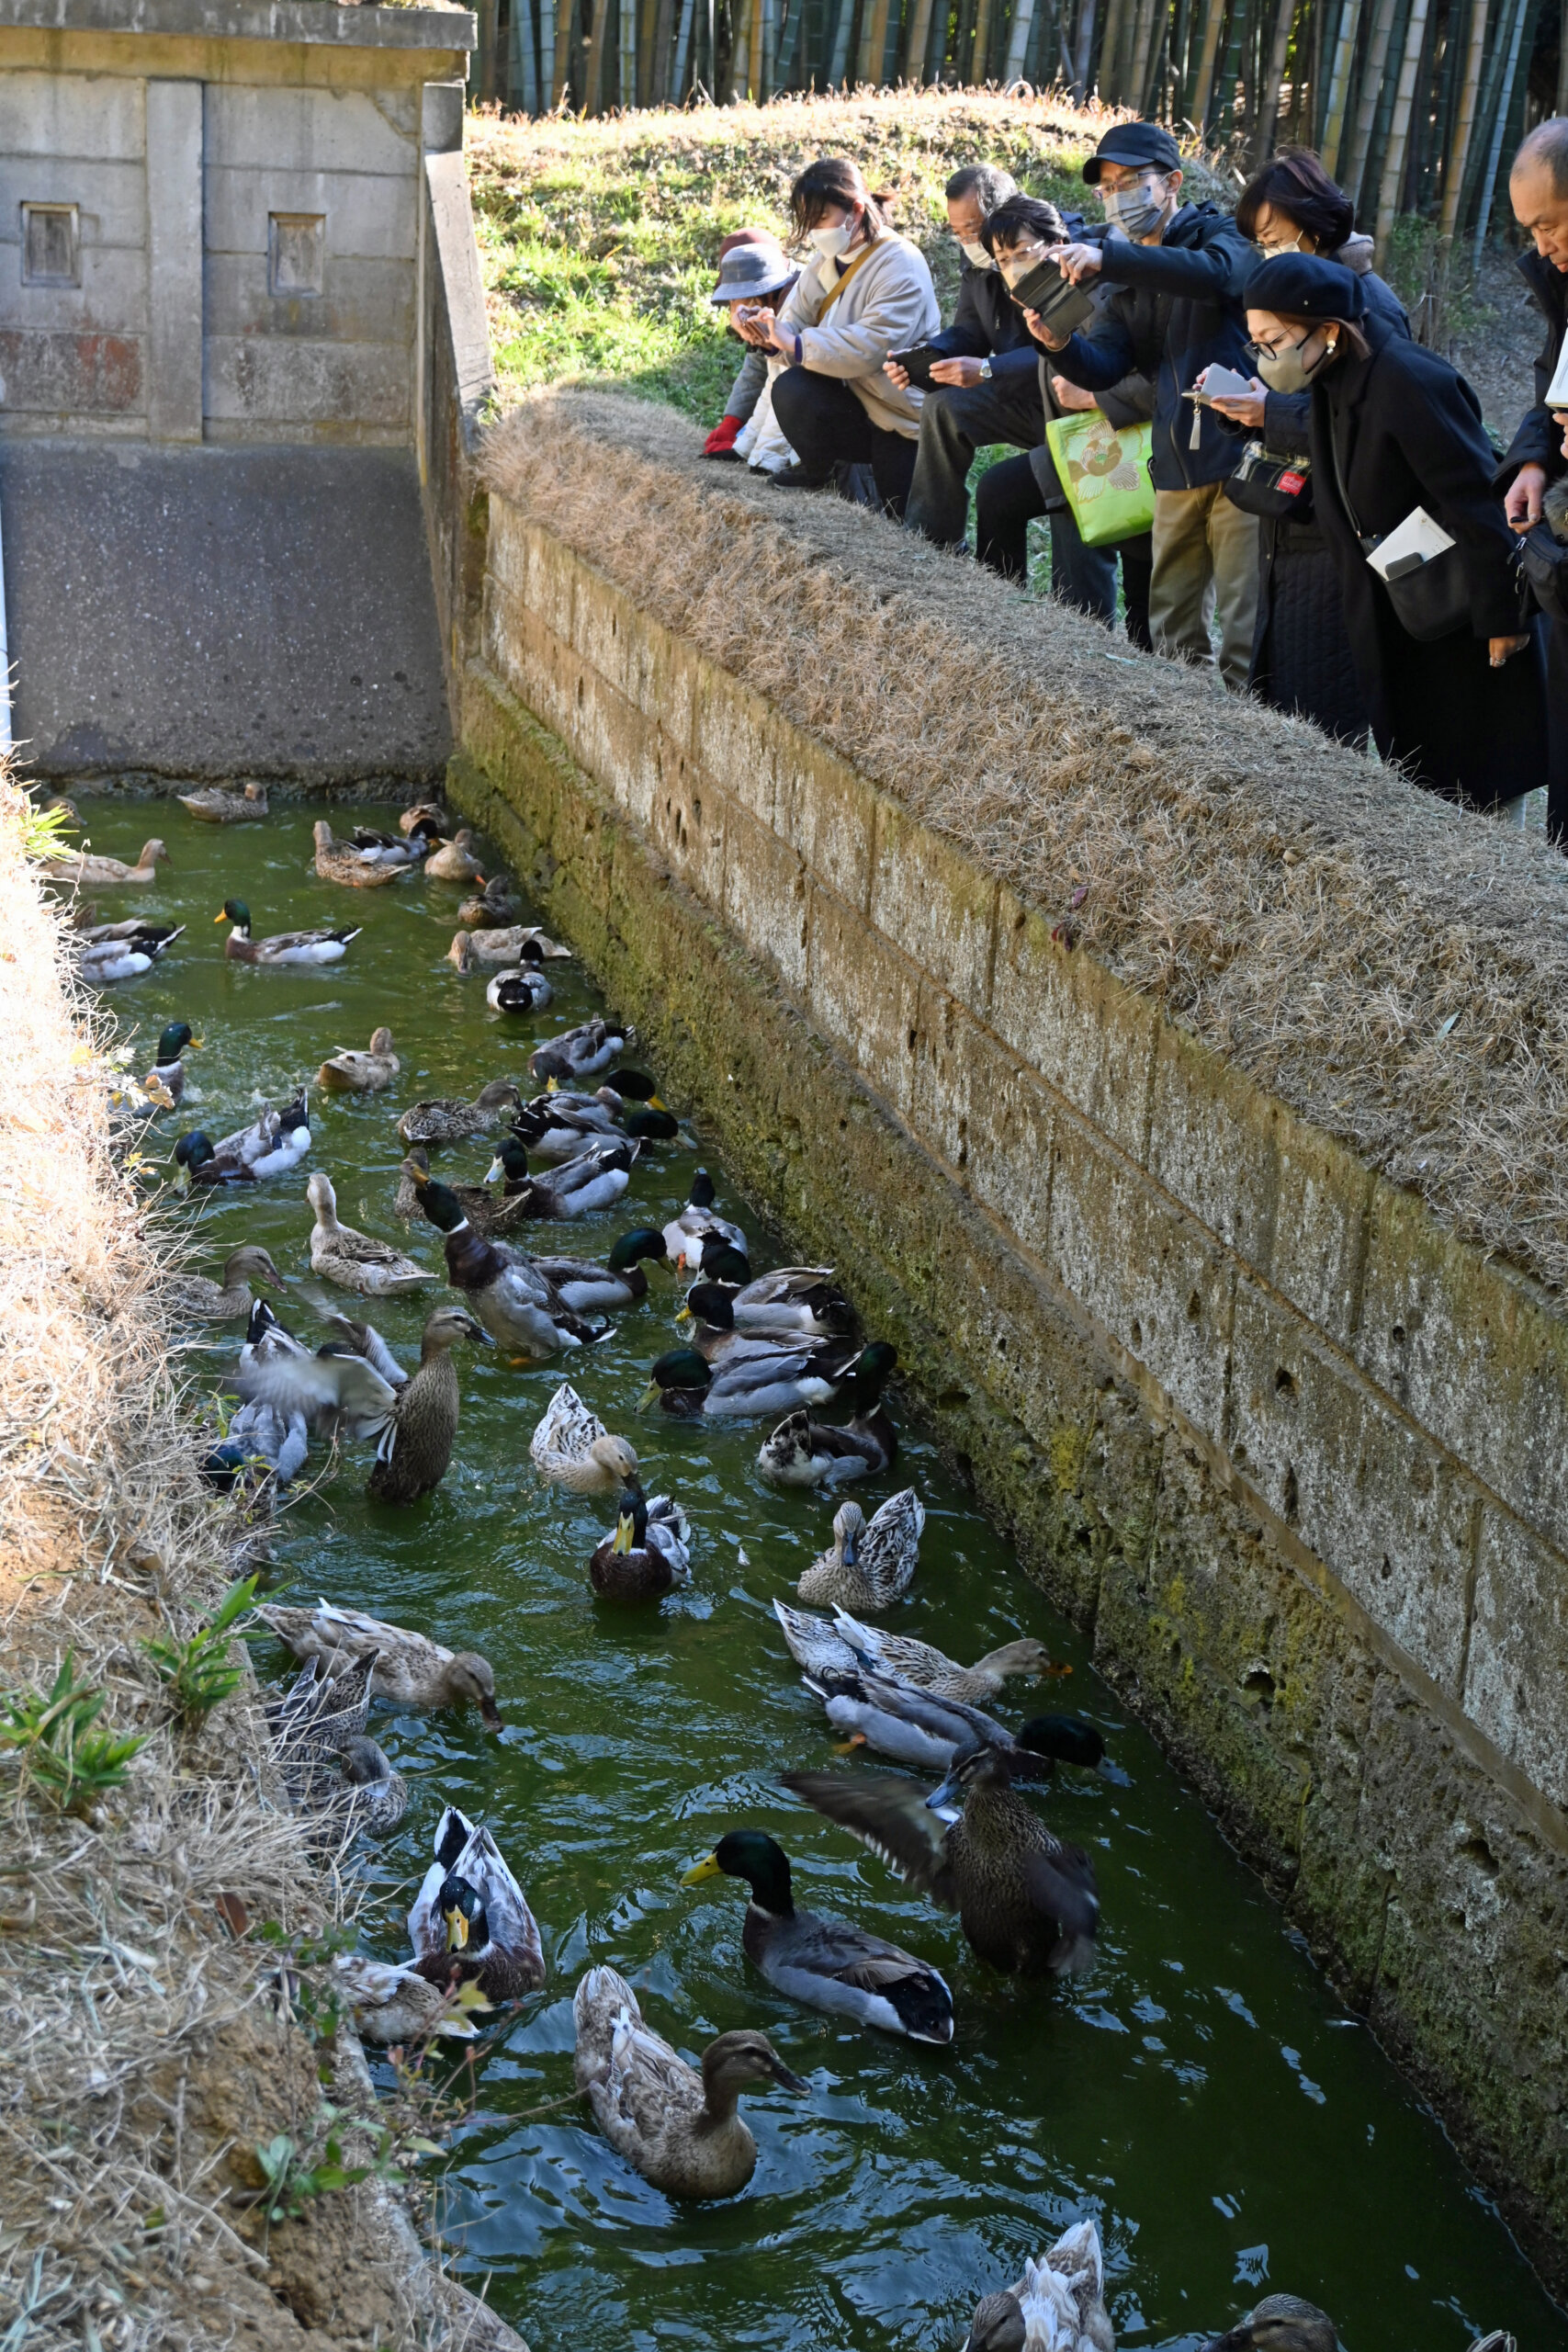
1055;205;1258;489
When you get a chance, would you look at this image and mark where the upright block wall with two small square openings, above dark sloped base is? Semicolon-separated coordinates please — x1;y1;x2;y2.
0;0;472;445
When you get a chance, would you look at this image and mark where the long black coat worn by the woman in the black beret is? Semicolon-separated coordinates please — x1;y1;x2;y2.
1309;312;1547;809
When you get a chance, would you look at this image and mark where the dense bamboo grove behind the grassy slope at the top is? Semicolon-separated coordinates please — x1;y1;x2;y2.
478;0;1568;254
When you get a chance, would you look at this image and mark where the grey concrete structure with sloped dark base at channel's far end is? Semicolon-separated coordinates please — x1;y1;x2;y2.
0;0;489;786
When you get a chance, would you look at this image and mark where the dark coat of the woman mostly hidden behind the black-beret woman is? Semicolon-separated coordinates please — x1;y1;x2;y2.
1248;253;1411;743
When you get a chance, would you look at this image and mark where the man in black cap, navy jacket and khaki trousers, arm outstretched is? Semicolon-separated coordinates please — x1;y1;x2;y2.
1039;122;1258;692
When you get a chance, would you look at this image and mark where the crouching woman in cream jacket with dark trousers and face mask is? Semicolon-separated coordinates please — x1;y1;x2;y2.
755;155;942;515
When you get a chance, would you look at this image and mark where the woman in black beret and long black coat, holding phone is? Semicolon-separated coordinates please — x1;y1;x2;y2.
1244;252;1547;809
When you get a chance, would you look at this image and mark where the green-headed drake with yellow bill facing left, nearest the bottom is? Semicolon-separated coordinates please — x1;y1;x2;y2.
682;1830;952;2044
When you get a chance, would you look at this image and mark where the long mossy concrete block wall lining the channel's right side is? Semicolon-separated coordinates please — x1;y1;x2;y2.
451;496;1568;2284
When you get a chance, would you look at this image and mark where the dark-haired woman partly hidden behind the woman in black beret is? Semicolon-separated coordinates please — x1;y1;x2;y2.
1215;148;1411;743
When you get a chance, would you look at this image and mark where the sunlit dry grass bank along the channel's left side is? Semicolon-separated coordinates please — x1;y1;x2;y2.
0;781;517;2352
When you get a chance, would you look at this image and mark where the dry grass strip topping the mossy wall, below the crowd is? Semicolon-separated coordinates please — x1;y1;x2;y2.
484;393;1568;1289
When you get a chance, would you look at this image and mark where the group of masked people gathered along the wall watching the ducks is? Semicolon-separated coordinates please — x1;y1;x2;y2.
705;118;1568;842
